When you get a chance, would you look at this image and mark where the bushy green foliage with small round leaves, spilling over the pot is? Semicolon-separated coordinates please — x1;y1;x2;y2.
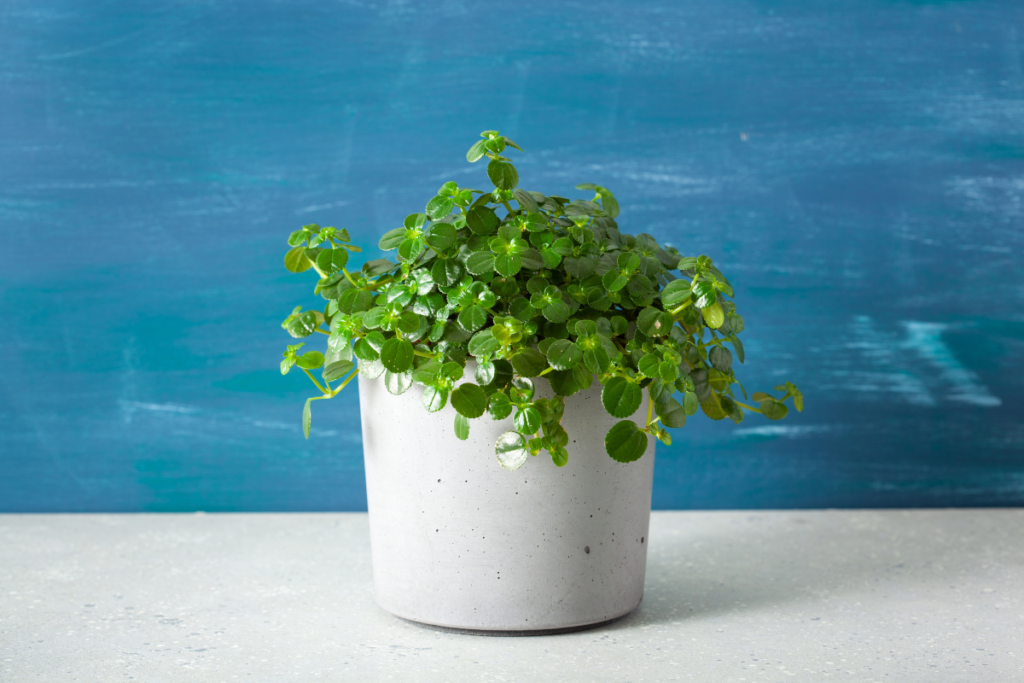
281;130;803;470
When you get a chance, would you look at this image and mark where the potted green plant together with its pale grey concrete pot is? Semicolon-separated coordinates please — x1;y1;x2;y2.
281;131;803;633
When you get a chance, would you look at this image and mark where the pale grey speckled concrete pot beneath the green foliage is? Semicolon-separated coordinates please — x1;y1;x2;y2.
358;373;655;632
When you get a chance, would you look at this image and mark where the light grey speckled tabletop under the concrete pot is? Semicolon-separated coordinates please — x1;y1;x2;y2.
0;510;1024;683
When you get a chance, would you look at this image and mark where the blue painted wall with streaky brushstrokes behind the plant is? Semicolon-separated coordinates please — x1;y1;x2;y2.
0;0;1024;511
